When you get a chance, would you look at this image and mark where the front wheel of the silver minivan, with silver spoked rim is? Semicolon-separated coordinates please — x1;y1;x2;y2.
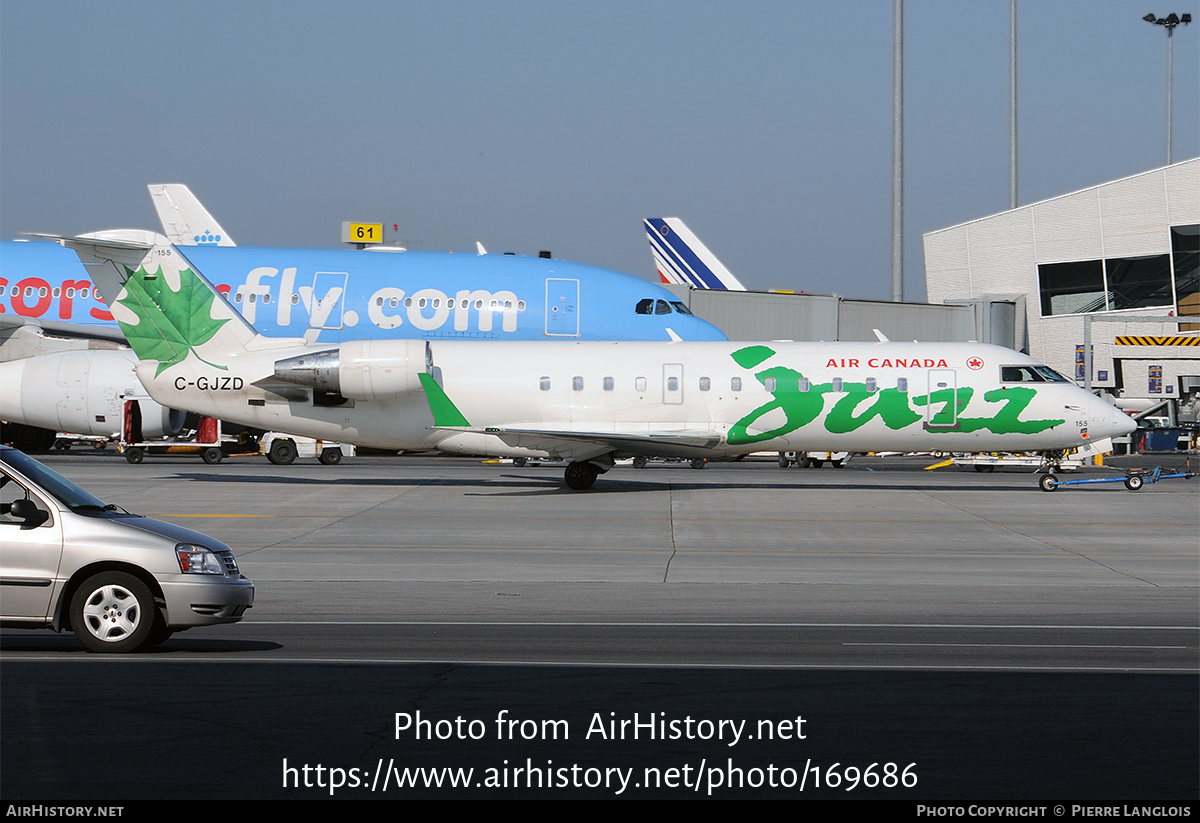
71;571;161;654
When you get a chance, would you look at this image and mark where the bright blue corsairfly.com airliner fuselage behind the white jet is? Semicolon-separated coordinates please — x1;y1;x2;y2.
0;241;725;342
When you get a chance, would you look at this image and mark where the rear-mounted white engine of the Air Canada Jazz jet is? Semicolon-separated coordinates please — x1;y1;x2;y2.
275;340;433;400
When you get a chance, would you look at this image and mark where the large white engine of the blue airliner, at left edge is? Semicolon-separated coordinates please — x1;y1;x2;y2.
0;349;186;438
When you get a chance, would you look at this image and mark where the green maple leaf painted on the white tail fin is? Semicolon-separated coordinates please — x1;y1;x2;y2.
116;268;229;377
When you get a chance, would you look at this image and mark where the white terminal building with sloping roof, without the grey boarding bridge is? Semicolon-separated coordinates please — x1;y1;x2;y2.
925;158;1200;413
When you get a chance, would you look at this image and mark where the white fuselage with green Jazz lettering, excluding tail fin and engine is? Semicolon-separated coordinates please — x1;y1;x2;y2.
138;338;1130;459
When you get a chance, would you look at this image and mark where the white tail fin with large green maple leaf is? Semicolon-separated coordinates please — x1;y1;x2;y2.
49;232;262;377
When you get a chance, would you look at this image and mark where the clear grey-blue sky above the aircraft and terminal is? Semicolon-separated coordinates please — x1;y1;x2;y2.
0;0;1200;300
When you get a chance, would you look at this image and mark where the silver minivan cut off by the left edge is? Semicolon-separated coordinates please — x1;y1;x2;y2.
0;446;254;653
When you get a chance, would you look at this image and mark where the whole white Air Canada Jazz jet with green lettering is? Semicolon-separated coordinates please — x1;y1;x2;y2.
64;232;1134;489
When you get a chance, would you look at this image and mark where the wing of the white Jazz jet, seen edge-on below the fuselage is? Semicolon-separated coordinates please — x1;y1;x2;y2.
438;426;721;461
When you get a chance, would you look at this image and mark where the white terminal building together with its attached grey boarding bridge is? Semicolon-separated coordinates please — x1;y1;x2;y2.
667;158;1200;423
